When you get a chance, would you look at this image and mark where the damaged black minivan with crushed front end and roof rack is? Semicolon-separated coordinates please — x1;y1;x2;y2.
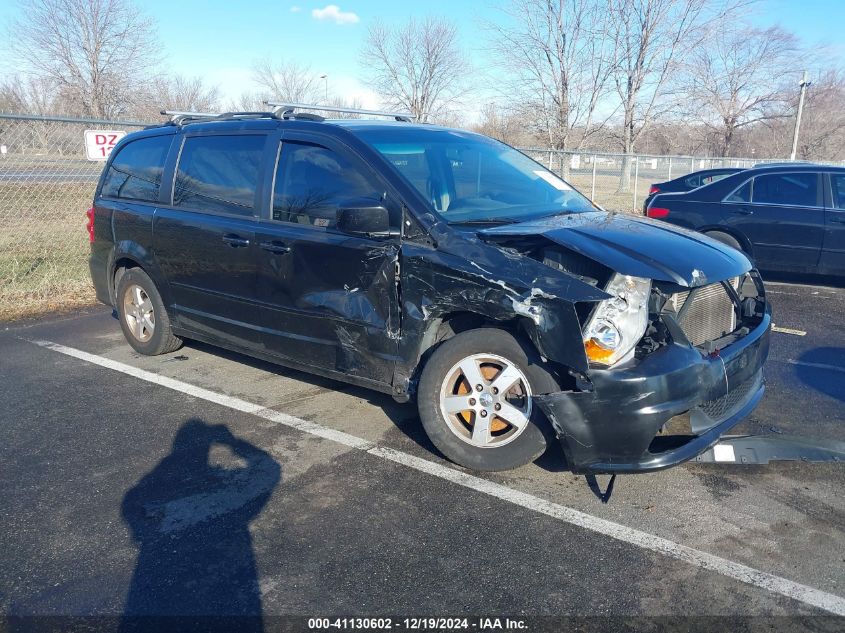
89;105;770;473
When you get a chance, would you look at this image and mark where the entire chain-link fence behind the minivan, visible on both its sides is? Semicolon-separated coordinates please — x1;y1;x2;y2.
0;114;836;320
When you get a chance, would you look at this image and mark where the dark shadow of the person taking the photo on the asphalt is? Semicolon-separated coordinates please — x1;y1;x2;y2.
121;419;281;631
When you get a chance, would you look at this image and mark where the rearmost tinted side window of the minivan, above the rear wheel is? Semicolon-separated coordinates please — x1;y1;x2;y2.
102;135;173;202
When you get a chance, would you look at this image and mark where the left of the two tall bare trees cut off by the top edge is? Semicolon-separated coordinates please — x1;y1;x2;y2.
488;0;611;165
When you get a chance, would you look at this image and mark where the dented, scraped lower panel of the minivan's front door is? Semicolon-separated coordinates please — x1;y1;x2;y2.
258;222;400;384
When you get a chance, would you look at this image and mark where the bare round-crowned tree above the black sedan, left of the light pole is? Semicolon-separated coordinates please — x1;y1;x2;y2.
685;27;798;156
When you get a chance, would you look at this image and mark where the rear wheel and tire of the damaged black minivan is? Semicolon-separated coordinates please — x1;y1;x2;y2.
115;268;182;356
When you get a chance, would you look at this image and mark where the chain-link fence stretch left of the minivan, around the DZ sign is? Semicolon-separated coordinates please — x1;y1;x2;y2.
0;115;140;320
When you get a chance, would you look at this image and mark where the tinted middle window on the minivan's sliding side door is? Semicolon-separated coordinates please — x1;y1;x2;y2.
173;134;265;215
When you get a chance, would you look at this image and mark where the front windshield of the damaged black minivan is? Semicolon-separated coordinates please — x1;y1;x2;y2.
356;127;596;224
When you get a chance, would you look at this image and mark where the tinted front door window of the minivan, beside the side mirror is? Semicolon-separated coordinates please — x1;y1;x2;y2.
273;142;382;227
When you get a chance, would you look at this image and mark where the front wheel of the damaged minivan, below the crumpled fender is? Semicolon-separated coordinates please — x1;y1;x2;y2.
417;328;560;471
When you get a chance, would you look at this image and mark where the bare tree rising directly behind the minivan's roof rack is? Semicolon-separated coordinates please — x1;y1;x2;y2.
362;17;469;122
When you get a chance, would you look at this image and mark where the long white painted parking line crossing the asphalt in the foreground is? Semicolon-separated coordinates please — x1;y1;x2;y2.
30;340;845;616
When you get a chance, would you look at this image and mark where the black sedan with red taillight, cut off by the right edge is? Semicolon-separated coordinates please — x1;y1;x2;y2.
646;164;845;275
